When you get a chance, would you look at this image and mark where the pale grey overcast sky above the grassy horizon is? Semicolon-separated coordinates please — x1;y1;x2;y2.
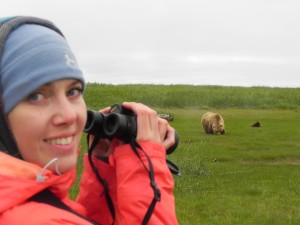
0;0;300;87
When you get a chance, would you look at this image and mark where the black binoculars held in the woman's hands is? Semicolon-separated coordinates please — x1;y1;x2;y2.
84;104;179;154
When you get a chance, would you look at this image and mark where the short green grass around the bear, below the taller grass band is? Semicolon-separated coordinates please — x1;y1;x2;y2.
169;109;300;225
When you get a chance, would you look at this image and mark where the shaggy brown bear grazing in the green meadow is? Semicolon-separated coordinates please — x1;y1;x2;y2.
201;112;225;134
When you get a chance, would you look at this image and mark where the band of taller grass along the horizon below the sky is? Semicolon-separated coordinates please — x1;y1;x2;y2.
86;84;300;109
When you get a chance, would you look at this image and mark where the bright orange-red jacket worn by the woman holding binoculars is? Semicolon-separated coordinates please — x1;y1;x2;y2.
0;142;178;225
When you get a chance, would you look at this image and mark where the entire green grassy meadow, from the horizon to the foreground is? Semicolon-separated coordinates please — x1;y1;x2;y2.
71;84;300;225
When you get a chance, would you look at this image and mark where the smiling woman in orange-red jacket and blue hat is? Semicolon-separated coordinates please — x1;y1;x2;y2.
0;17;177;225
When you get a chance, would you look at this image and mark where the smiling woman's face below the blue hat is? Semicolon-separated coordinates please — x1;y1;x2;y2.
8;79;87;173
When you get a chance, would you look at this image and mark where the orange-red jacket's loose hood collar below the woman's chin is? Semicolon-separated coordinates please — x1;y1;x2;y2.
0;152;76;214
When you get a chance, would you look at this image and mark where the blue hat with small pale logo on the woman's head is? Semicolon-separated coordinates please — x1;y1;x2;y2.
0;24;85;114
